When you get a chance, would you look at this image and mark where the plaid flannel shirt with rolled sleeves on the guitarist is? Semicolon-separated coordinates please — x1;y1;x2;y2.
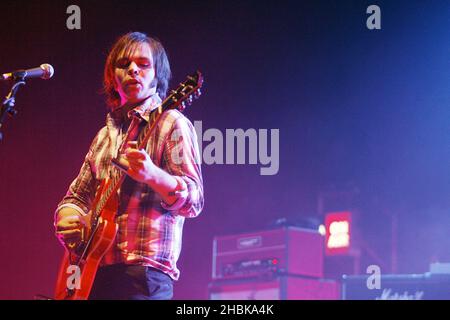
57;94;204;280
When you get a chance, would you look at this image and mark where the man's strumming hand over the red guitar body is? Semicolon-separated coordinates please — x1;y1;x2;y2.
55;207;88;247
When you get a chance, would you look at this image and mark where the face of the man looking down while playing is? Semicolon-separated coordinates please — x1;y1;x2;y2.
114;43;156;106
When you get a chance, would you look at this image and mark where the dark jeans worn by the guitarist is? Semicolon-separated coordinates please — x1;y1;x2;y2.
89;264;173;300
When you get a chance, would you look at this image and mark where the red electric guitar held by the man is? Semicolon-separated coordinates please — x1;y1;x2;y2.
55;71;203;300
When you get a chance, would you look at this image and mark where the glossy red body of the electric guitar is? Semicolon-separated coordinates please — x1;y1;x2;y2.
55;180;118;300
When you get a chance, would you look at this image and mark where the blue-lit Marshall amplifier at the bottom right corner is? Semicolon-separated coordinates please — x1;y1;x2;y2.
342;273;450;300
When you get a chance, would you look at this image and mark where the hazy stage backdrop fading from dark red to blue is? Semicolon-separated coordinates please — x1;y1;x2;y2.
0;0;450;299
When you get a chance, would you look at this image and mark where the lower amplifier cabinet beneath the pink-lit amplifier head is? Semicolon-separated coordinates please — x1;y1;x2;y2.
209;276;340;300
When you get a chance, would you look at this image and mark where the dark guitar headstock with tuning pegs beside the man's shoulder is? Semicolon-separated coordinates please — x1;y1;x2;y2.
162;70;203;112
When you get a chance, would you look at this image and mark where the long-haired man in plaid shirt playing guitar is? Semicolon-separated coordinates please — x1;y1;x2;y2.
55;32;204;299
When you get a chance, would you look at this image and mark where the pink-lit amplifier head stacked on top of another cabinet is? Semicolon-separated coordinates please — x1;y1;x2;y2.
212;227;324;279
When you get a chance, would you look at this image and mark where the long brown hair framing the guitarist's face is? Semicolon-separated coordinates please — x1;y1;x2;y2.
103;32;171;107
